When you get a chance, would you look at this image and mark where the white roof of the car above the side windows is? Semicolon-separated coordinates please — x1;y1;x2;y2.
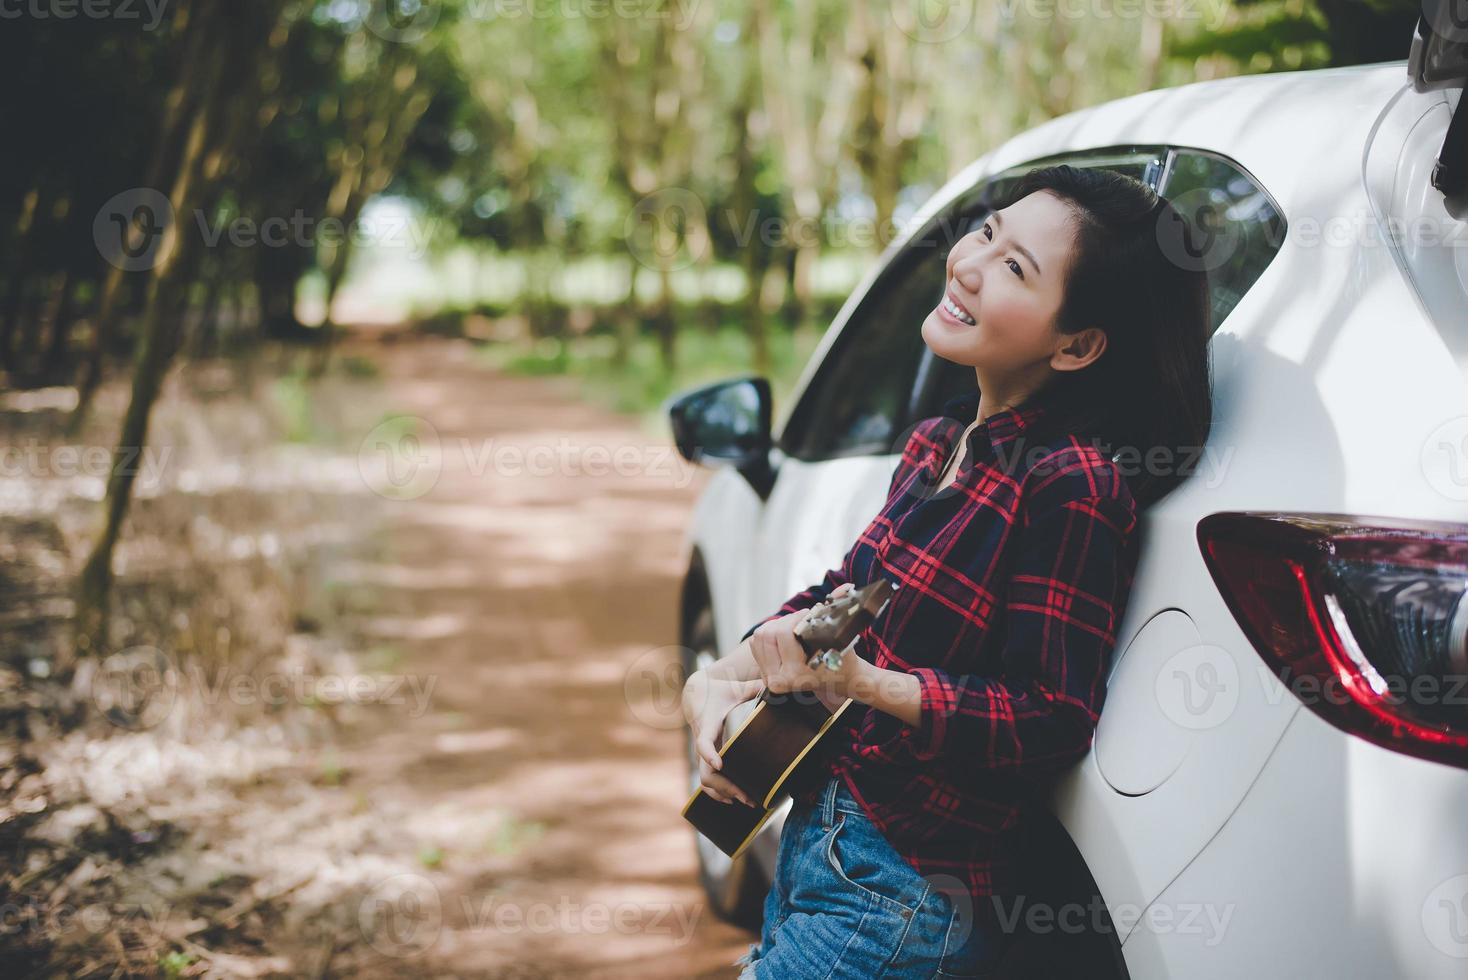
909;59;1411;227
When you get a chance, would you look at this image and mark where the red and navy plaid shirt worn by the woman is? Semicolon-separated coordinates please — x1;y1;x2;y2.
744;390;1136;911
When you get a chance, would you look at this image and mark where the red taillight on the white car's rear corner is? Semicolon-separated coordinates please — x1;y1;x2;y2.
1198;512;1468;767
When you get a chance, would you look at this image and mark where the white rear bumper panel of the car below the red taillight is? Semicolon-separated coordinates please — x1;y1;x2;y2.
1123;710;1468;980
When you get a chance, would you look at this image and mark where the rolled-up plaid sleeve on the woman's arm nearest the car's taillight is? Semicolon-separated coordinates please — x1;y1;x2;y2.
875;474;1136;778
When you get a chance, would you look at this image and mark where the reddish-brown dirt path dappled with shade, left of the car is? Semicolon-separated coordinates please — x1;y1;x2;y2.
330;334;750;980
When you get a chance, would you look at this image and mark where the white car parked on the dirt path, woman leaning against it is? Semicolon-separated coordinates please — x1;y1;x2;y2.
668;25;1468;980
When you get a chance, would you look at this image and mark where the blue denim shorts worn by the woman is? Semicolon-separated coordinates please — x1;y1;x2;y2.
733;776;1006;980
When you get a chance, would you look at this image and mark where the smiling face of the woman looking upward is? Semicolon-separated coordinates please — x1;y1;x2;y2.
922;191;1075;387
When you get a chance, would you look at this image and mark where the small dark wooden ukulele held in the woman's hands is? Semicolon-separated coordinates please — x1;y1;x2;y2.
683;578;897;858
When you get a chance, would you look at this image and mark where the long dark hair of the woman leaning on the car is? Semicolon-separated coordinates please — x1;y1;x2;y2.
992;164;1213;506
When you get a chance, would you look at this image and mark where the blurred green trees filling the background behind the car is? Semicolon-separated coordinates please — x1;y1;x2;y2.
0;0;1417;637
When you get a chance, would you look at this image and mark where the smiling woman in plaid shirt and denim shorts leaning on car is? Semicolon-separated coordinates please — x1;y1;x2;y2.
684;166;1211;980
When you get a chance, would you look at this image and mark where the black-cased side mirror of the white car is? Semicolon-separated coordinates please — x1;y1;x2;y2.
666;377;775;499
